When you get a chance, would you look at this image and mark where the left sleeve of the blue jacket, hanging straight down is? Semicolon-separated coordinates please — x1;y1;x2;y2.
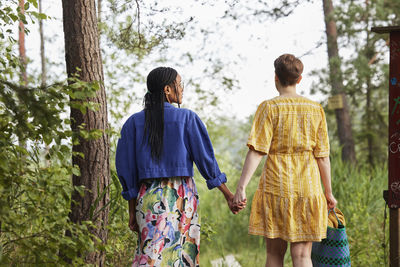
115;123;139;200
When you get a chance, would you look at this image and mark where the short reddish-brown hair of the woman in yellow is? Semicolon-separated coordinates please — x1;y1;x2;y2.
274;54;304;86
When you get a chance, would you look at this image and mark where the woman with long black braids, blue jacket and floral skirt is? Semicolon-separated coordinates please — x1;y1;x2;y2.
116;67;246;266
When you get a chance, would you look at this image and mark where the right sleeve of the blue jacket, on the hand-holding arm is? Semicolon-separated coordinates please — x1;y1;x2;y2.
186;113;227;189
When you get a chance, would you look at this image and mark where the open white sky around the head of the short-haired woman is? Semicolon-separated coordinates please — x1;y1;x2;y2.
180;0;328;118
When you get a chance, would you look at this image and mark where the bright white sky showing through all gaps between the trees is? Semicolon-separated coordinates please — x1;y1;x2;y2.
26;0;327;119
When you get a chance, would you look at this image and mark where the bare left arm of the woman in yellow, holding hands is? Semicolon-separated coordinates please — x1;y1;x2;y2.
233;148;265;205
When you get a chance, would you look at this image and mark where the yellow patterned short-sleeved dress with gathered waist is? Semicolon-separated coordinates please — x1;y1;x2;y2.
247;97;329;242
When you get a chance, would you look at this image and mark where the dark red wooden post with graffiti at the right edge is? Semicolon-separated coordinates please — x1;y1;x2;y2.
371;26;400;267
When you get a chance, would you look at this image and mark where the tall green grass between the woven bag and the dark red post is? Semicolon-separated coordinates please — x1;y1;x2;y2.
332;150;389;266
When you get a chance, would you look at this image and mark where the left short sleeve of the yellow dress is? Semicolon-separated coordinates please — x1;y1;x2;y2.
247;102;274;154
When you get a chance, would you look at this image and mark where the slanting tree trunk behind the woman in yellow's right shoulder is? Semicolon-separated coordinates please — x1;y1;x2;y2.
322;0;356;163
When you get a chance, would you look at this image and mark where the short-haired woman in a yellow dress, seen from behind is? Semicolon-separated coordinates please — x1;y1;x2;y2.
234;54;337;267
